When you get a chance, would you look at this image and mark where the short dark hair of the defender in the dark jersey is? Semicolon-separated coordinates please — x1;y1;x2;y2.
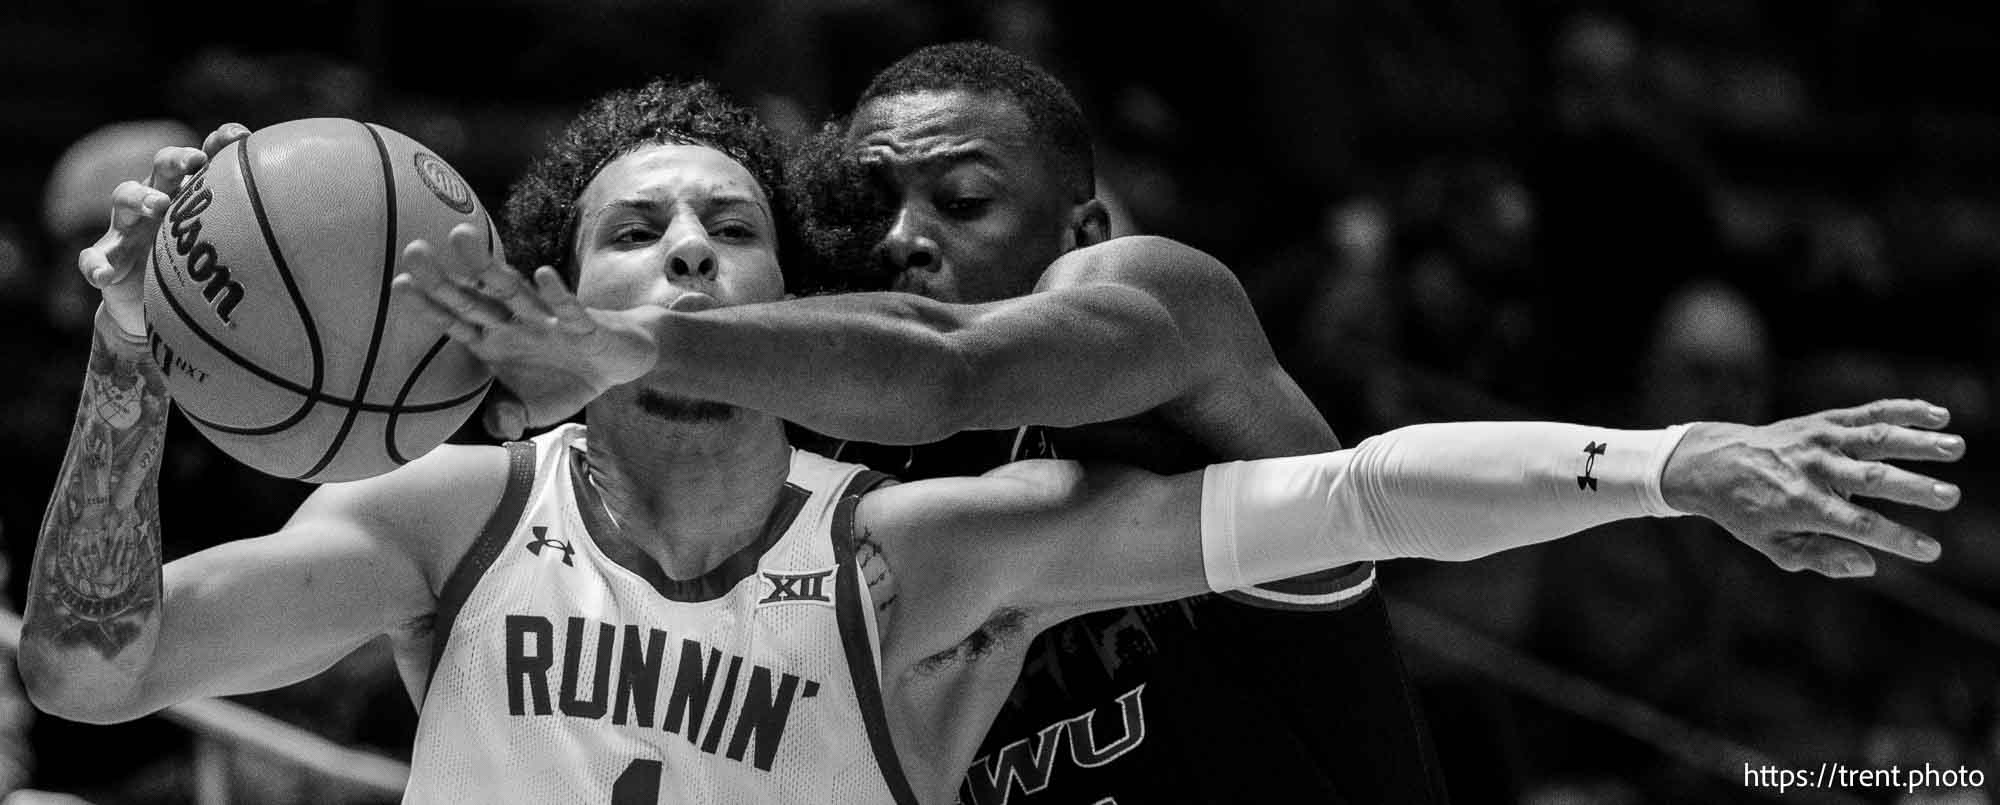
854;42;1096;200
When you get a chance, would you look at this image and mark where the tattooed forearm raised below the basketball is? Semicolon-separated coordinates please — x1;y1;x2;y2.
26;330;168;661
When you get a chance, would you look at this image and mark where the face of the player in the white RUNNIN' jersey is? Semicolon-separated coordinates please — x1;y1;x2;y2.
576;144;784;310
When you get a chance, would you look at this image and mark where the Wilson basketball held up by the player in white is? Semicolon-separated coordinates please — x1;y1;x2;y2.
146;118;500;483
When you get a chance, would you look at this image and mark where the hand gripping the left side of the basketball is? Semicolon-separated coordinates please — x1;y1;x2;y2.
76;122;250;336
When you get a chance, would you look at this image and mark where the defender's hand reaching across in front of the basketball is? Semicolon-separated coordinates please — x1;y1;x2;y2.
392;224;658;439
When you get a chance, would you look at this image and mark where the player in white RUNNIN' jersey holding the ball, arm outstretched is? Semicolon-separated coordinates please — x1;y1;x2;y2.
20;77;1962;803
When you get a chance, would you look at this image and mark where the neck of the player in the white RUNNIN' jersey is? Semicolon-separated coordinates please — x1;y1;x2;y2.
578;390;792;579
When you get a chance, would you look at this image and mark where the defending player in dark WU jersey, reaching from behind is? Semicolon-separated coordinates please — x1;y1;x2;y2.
802;44;1444;805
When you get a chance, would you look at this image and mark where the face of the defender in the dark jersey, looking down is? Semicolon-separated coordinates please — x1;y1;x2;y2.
848;90;1076;302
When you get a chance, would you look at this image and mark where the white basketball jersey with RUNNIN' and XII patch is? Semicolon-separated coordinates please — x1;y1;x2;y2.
404;425;914;805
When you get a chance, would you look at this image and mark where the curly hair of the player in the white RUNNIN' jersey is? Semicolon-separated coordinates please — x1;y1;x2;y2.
504;78;810;290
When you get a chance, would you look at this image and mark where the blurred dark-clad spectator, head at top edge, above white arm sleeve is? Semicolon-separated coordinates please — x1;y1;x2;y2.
1530;14;1718;421
